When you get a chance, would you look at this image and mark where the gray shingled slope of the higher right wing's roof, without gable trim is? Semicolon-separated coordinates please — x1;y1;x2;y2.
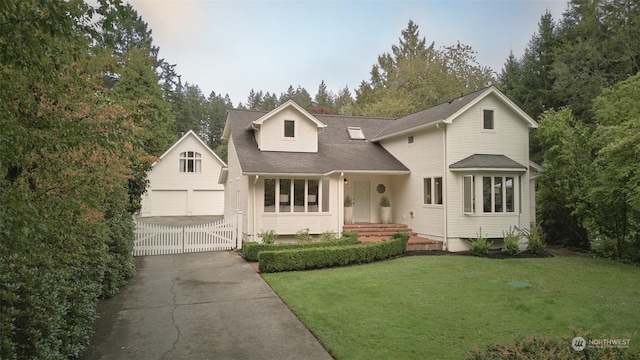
374;88;488;140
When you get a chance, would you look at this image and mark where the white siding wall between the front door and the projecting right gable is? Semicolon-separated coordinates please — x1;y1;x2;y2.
382;127;446;239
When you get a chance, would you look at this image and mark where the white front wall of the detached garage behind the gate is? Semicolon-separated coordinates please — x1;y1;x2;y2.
141;135;224;216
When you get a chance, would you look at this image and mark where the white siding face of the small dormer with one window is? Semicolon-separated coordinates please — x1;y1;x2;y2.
257;107;318;152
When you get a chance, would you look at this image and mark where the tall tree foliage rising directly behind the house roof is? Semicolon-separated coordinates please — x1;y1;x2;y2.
355;20;494;117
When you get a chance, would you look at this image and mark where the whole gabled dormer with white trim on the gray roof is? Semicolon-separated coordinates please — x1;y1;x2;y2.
251;100;326;153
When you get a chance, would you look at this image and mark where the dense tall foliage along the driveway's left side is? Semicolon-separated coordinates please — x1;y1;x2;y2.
0;0;178;359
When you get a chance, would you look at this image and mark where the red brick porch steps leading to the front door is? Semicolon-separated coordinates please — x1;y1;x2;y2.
342;224;443;251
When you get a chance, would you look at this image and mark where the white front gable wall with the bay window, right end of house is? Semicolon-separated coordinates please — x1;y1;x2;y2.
446;95;530;243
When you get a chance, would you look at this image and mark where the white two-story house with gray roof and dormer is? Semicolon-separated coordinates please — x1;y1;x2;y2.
219;87;540;251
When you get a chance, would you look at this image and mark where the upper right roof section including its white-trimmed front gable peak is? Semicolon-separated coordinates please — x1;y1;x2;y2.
373;86;538;141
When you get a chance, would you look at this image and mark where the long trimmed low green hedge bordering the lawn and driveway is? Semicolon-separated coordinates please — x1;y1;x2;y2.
258;236;407;273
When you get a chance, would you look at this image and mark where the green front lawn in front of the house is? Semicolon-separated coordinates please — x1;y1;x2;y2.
263;256;640;360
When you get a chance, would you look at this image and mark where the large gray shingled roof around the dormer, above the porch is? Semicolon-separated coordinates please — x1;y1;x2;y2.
227;109;409;174
